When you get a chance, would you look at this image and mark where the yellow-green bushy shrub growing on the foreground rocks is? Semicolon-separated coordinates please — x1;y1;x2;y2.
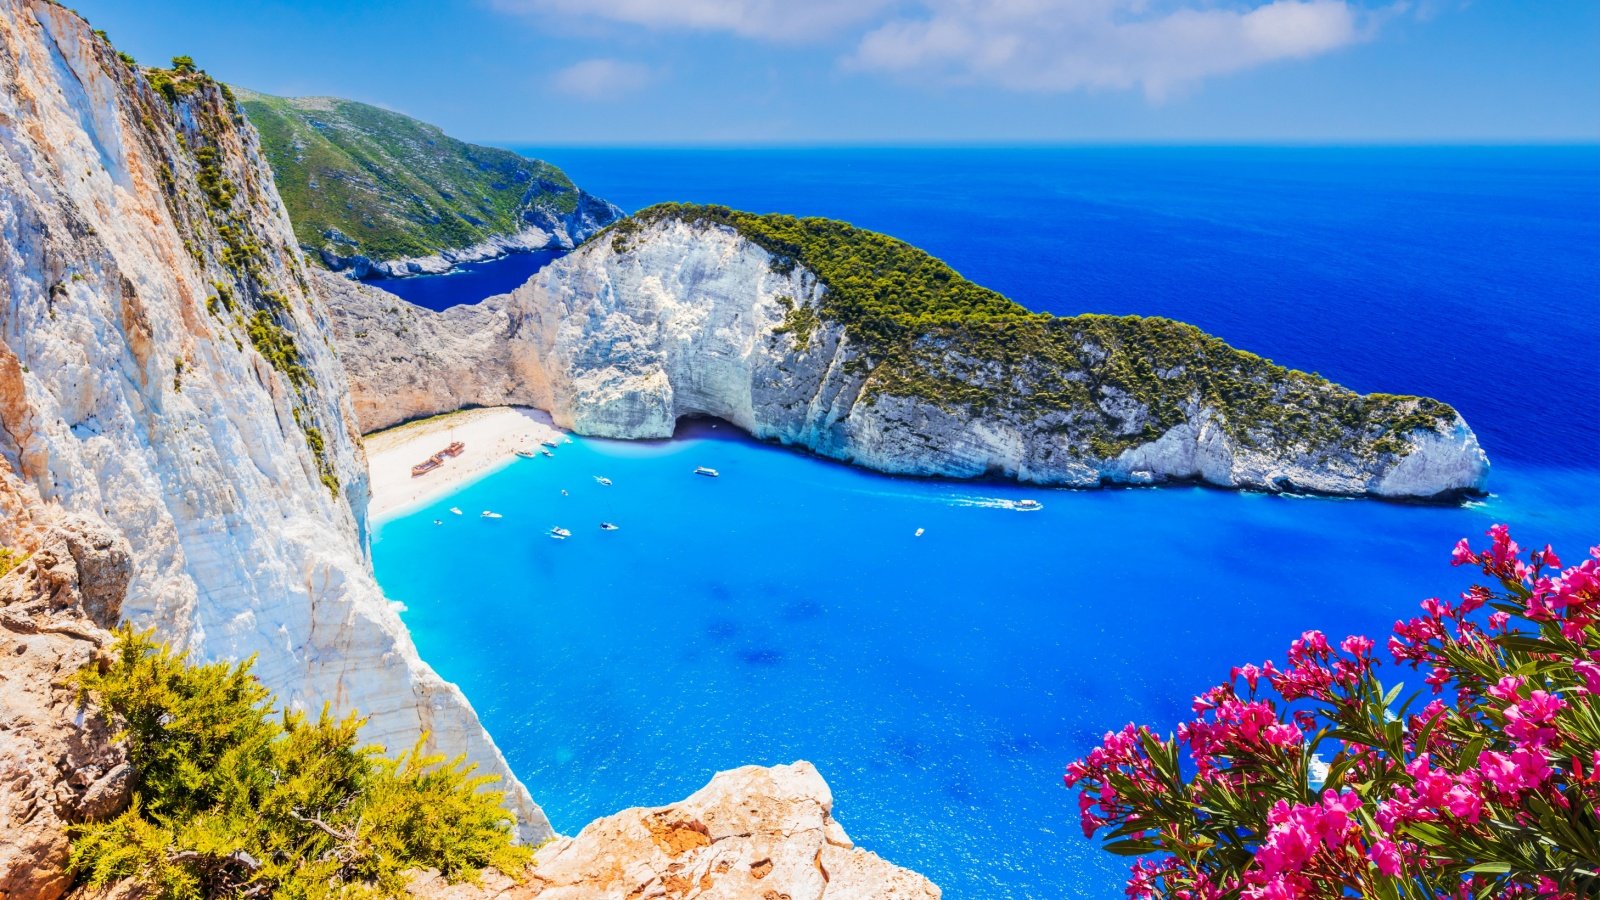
72;626;531;900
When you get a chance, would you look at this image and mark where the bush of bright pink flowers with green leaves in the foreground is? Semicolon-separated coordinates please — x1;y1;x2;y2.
1066;525;1600;900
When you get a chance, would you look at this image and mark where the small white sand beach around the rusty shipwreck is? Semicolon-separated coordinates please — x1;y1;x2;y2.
363;407;563;522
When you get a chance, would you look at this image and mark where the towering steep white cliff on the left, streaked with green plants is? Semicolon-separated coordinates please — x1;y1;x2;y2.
0;0;550;839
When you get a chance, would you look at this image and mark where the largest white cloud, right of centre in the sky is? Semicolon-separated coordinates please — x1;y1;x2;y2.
846;0;1376;99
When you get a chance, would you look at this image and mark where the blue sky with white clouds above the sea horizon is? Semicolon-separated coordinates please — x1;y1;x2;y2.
69;0;1600;146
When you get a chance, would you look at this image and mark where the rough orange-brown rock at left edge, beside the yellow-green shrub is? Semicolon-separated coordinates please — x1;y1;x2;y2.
0;511;133;900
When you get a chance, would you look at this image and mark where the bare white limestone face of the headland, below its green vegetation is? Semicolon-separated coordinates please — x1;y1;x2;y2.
326;218;1488;498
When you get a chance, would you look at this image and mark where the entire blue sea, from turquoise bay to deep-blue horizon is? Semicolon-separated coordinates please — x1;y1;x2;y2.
373;147;1600;900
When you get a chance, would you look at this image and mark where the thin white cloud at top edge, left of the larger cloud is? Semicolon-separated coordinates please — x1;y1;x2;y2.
490;0;893;42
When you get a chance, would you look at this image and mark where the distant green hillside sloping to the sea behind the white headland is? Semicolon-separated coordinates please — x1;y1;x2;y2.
238;90;611;259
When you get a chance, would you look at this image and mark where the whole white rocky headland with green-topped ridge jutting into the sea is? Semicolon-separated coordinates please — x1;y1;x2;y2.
324;215;1488;498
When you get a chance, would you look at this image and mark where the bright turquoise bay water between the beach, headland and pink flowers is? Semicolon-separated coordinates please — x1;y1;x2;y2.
373;424;1600;898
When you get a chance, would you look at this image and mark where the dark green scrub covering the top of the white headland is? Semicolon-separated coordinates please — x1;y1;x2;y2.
605;203;1456;456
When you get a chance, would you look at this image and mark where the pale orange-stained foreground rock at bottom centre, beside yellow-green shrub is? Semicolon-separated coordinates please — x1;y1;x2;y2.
411;762;939;900
